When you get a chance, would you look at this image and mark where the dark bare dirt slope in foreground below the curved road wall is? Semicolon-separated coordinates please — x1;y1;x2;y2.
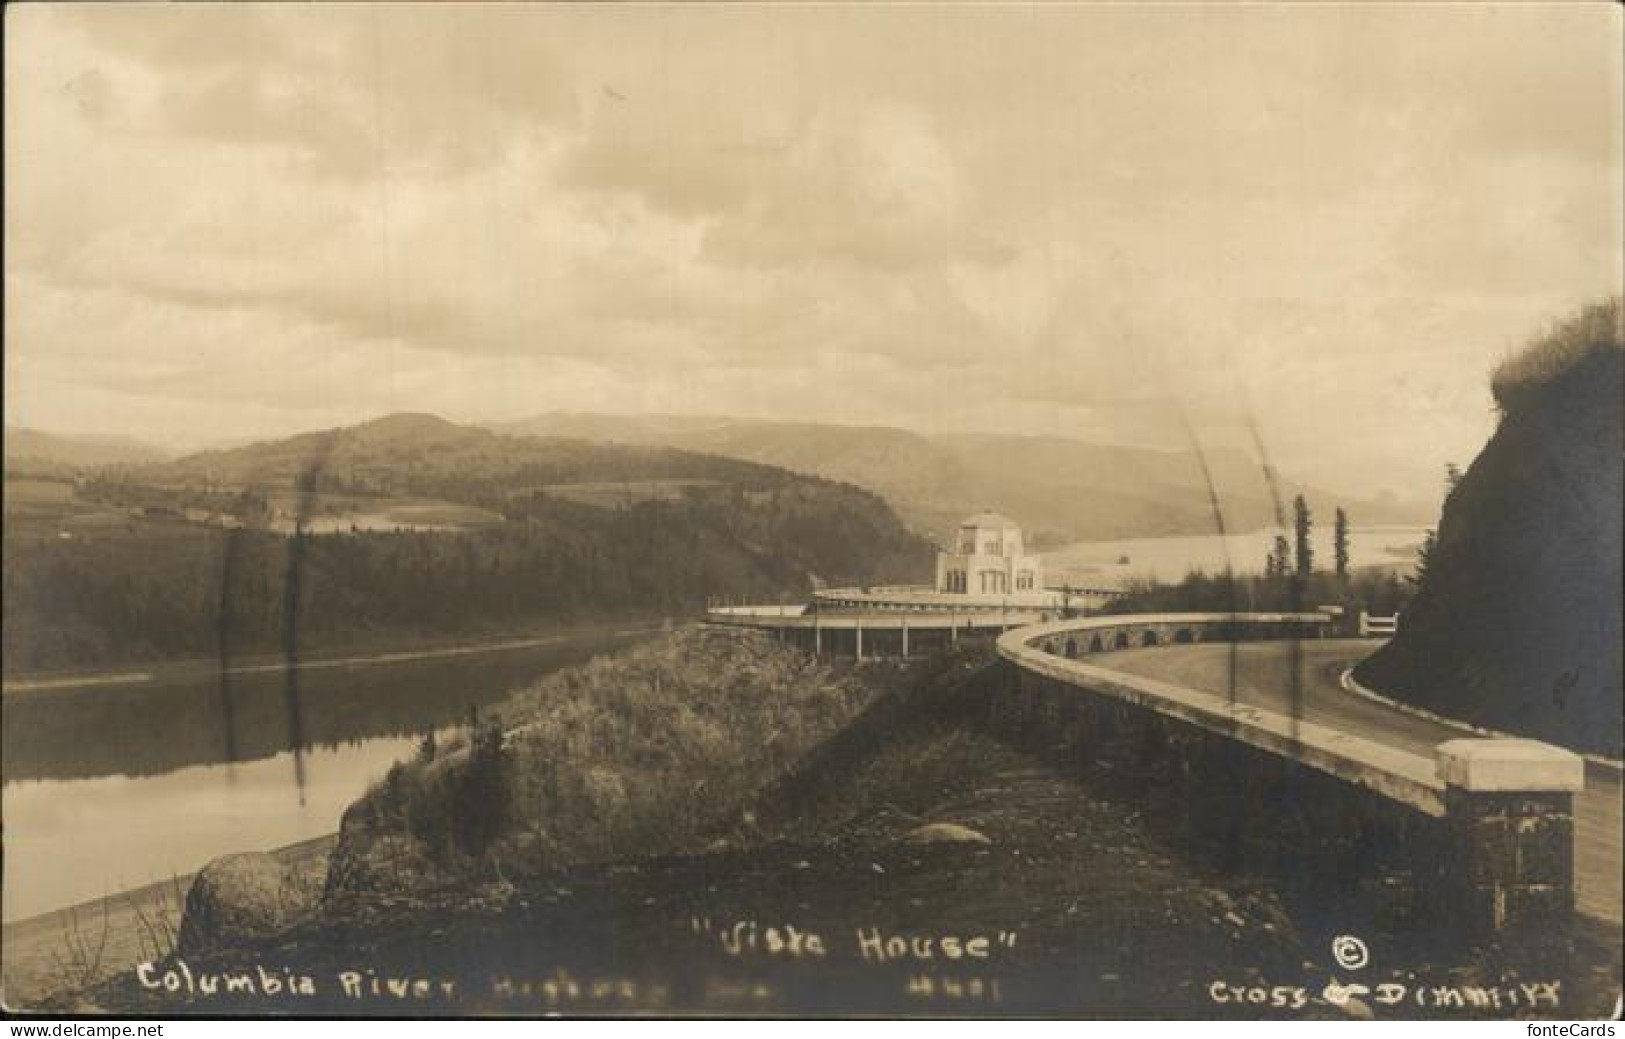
57;634;1617;1018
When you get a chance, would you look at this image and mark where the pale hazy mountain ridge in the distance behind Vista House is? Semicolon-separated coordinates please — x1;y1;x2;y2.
491;411;1432;545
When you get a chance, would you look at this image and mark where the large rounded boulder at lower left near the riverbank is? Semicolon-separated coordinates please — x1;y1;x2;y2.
176;852;327;956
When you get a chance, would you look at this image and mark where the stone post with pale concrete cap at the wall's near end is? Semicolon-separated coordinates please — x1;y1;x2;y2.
1435;740;1586;933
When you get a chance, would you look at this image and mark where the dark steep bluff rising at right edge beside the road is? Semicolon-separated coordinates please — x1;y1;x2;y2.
1359;299;1625;758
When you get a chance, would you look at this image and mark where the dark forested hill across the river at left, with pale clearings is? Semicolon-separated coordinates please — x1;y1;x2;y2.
3;416;930;673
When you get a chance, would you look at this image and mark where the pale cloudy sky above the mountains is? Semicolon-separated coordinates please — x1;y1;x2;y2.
5;3;1625;500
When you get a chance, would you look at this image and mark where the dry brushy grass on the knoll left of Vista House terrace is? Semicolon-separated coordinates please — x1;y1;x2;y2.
369;629;871;872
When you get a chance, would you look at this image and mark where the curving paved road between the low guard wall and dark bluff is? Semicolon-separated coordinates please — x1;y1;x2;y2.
1089;639;1625;924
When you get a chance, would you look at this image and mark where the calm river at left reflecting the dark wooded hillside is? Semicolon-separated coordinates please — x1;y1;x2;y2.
0;628;648;920
